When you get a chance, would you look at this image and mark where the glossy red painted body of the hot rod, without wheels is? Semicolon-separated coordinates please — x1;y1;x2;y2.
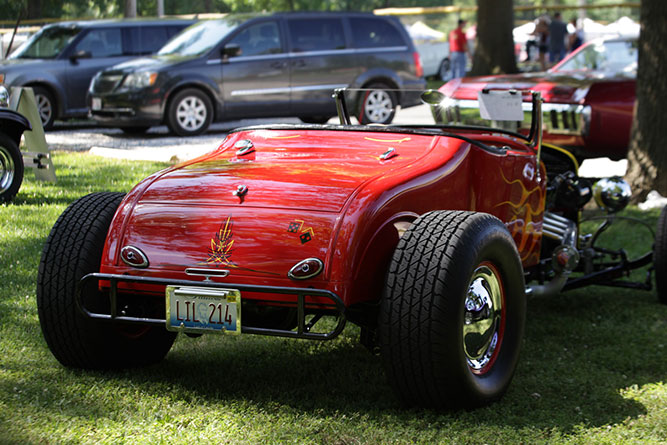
101;126;545;306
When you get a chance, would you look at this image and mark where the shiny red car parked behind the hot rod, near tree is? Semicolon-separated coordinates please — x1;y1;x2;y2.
440;37;637;159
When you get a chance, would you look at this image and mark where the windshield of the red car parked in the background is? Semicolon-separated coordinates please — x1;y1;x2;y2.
558;40;637;74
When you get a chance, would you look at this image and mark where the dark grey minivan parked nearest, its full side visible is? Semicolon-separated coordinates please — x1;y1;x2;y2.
89;13;425;135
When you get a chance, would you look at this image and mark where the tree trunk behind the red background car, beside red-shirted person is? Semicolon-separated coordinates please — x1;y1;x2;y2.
470;0;517;76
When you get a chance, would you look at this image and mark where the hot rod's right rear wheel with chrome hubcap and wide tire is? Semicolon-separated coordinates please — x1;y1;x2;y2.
379;211;526;408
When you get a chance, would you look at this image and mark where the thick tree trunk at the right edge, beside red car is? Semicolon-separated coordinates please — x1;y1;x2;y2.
626;0;667;202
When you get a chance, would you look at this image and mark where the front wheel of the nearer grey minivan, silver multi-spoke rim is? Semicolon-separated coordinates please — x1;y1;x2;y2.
167;88;213;136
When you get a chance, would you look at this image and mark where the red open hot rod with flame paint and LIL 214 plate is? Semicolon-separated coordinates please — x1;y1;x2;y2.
37;87;667;407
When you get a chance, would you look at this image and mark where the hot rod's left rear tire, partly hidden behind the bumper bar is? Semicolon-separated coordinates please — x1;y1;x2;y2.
37;193;175;369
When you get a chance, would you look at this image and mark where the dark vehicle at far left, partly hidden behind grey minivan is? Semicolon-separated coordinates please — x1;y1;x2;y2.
0;20;194;129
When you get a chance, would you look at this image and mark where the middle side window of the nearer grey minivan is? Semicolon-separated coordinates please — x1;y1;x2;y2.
287;18;345;52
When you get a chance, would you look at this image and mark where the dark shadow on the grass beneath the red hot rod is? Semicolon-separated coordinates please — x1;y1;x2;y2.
14;288;656;433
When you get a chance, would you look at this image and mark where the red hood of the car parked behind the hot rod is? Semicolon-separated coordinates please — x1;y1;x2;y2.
441;71;629;103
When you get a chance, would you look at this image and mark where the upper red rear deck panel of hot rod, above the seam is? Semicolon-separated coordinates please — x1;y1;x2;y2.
137;129;433;212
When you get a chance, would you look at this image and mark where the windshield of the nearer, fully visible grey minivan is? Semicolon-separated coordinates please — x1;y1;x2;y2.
158;20;236;56
